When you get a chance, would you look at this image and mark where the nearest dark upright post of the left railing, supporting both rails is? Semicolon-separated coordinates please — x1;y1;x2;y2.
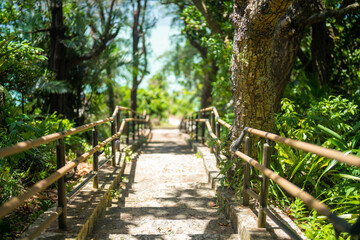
56;138;67;229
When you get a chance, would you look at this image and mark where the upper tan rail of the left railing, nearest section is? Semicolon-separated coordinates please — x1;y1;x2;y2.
0;117;114;158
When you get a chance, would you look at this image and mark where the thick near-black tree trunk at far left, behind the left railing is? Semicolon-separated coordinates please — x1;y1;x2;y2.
49;0;66;114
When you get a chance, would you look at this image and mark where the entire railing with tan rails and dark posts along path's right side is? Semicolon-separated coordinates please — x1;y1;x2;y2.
180;107;360;239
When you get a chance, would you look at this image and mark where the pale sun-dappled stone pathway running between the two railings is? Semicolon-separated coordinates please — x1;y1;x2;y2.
90;130;238;240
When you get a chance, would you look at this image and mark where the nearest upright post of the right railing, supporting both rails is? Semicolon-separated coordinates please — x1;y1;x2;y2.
258;143;271;228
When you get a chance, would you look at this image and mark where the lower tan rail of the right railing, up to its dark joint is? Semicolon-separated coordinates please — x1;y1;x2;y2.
235;151;331;216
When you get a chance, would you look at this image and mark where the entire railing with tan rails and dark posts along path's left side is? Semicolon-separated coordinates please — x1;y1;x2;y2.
0;106;151;239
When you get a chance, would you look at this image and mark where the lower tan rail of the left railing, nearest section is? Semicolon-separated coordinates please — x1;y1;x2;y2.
0;131;121;219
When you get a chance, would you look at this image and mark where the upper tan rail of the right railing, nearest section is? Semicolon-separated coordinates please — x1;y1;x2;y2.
245;128;360;167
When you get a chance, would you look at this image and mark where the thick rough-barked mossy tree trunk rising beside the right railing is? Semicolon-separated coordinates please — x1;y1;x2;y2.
231;0;332;137
